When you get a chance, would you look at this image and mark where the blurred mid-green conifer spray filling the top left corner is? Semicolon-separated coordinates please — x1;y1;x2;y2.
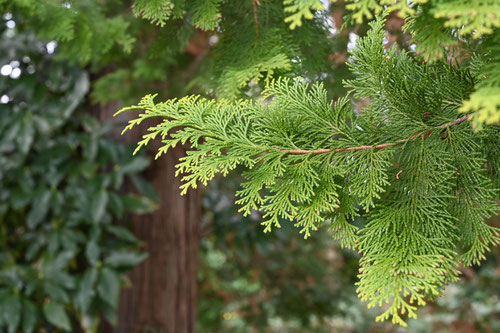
0;0;134;64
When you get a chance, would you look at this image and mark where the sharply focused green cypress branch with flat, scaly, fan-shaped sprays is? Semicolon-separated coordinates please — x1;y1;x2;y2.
115;19;500;325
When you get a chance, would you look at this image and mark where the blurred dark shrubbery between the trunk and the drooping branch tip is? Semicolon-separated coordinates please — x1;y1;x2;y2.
198;172;372;332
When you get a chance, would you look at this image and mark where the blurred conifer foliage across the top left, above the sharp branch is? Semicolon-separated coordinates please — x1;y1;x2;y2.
0;0;348;104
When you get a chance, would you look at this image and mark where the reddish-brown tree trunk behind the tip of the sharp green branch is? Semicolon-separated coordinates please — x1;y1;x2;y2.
94;101;201;333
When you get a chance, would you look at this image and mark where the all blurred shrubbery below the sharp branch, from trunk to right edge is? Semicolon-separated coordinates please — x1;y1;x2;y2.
198;172;500;333
